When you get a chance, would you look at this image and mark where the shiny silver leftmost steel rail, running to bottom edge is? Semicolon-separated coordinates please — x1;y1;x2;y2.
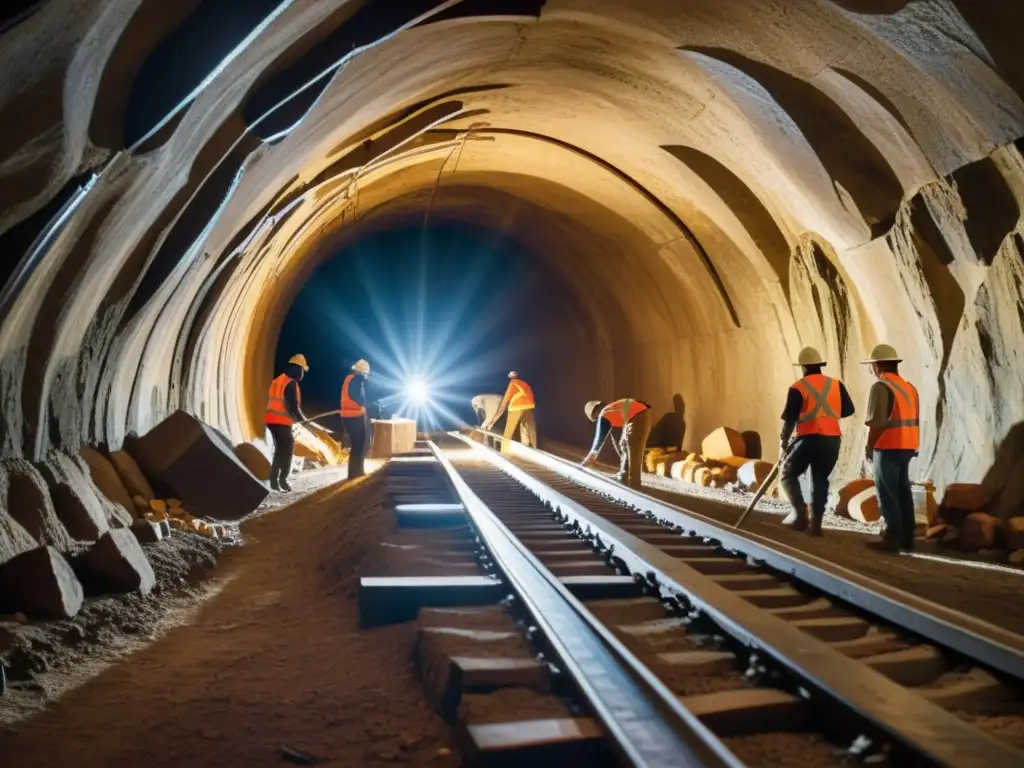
428;441;742;768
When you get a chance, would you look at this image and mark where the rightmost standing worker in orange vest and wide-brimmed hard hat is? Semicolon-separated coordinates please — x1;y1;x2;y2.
863;344;921;552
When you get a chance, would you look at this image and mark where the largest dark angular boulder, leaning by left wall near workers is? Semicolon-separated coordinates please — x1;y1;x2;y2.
129;411;269;520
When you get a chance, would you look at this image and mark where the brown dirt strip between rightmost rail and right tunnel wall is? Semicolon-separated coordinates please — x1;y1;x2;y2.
545;444;1024;635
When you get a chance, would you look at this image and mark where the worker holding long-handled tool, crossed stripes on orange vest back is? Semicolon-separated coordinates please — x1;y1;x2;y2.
779;347;854;536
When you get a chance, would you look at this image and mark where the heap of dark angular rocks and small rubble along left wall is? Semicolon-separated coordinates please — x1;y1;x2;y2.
0;411;268;620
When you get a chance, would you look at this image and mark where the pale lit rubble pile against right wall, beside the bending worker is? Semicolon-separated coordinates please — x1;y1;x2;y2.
644;427;775;490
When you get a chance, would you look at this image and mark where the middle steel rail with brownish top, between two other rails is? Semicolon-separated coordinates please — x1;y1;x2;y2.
452;433;1024;768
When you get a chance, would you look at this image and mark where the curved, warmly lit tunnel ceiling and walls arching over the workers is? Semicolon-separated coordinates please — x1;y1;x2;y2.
0;0;1024;501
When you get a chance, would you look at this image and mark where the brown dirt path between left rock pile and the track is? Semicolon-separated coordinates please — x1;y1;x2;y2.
0;468;455;768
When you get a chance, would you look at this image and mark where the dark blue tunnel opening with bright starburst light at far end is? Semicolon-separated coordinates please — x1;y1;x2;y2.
274;219;593;438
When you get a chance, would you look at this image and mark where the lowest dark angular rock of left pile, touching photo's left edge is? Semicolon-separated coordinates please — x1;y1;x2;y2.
0;547;84;618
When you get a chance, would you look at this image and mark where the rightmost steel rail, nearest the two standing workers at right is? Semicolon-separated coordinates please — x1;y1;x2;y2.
468;430;1024;681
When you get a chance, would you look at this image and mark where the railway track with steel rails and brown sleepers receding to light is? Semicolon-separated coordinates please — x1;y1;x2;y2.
360;436;1024;767
